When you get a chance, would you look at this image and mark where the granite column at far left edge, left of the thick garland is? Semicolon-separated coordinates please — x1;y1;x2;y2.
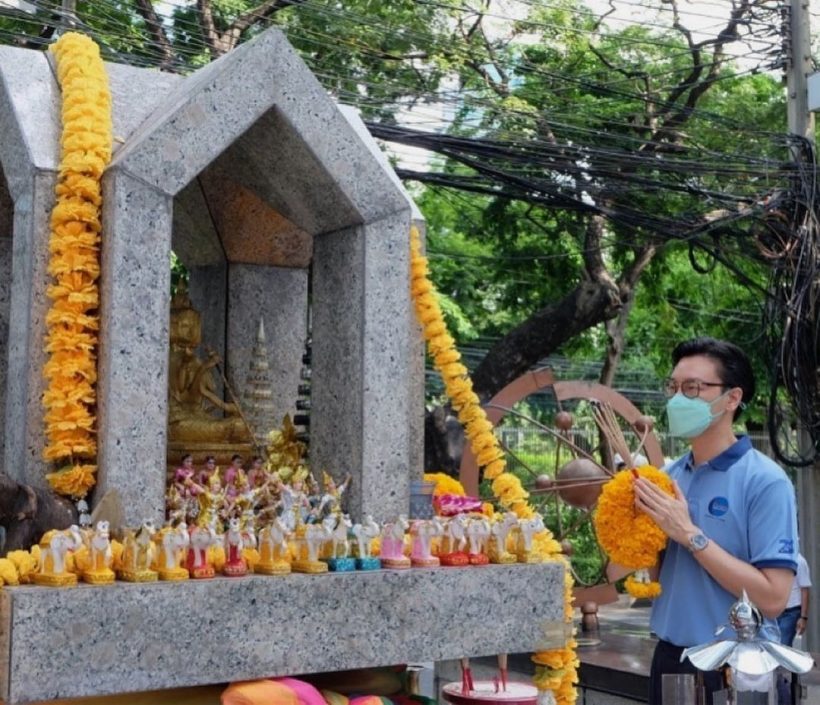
5;170;56;486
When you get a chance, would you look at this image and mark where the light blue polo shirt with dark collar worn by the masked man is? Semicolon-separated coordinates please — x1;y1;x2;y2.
650;436;798;646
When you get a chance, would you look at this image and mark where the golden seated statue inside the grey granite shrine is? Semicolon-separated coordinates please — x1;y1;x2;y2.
168;285;253;458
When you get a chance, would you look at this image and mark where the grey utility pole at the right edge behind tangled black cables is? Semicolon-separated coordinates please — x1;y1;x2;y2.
783;0;820;651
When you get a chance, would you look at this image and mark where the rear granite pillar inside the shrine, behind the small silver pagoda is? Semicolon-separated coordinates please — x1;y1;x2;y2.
227;264;308;426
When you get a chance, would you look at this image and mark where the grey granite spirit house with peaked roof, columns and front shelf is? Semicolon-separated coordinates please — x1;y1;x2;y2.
0;29;563;703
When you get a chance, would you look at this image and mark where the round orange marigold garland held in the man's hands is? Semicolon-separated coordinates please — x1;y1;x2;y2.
593;465;675;597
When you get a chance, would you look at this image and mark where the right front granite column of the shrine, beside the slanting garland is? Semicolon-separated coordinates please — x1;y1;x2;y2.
310;210;422;520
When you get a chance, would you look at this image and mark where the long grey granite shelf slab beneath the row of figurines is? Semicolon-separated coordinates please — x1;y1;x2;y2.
0;563;564;705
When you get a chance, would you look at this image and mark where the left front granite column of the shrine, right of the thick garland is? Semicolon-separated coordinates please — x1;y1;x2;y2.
95;169;172;526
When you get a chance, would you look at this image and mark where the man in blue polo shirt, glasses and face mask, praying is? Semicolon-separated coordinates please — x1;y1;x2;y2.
635;338;798;705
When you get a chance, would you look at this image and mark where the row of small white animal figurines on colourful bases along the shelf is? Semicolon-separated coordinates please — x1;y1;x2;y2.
28;513;544;586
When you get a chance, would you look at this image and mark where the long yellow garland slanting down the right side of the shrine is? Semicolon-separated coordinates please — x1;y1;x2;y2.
410;226;579;705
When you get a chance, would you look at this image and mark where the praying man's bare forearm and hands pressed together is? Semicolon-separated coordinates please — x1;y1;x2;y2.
635;478;794;619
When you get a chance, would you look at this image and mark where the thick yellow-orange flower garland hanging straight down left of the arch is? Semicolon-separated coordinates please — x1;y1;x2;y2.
43;32;112;499
